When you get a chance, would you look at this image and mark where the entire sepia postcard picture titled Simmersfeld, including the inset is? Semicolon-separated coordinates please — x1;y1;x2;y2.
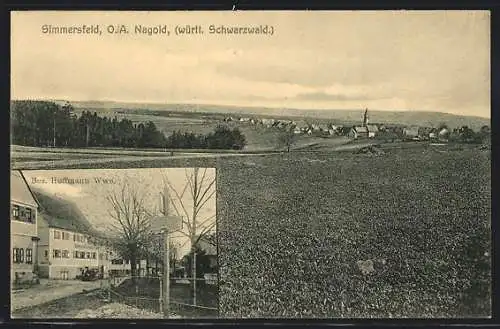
10;10;493;319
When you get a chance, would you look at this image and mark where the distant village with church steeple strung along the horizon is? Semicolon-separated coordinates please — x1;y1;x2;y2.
223;109;488;141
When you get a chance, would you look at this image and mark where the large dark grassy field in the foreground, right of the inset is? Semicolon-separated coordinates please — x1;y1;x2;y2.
217;146;491;318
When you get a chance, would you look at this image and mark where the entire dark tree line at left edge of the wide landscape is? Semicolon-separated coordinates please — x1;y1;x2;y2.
11;101;246;149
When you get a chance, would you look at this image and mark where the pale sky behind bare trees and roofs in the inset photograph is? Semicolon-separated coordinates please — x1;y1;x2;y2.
23;168;216;257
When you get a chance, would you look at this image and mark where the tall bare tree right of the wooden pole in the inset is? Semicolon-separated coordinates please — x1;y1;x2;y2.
163;168;216;305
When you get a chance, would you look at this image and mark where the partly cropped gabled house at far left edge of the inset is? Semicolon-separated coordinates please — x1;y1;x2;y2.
10;170;39;283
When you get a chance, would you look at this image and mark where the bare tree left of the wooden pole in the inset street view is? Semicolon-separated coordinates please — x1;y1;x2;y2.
106;181;151;282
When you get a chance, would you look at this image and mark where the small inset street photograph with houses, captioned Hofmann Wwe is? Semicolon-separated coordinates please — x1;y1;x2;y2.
10;168;218;319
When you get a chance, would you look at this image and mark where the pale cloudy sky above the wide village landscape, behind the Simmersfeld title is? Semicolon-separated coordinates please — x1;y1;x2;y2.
11;11;490;117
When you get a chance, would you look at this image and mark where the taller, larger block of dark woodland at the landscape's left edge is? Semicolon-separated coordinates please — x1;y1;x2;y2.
11;101;166;147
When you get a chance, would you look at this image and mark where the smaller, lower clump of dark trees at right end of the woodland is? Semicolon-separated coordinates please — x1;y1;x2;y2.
166;125;246;150
